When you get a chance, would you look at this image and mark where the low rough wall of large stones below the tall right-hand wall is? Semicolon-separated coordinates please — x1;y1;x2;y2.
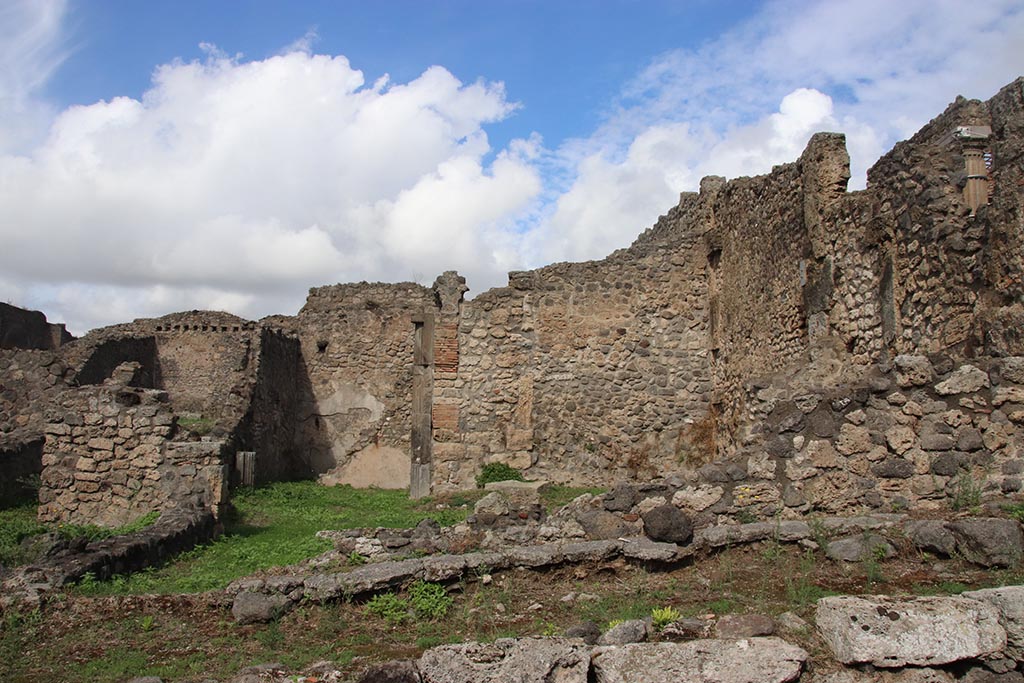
663;355;1024;521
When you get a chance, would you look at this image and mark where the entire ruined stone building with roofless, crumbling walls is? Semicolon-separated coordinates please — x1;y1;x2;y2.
0;79;1024;523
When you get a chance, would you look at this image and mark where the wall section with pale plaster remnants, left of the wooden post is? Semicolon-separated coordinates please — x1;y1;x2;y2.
288;283;436;488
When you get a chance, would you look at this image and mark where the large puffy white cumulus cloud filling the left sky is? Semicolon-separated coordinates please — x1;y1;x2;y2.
0;36;540;331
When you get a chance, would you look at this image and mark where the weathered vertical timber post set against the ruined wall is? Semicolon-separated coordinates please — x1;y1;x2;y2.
409;311;434;499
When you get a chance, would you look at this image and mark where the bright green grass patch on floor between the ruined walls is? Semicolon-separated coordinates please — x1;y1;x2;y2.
71;481;468;595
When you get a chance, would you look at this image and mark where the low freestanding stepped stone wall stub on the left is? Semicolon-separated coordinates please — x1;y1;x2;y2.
39;373;227;526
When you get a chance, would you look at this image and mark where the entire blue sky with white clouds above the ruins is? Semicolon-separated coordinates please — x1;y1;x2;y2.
0;0;1024;334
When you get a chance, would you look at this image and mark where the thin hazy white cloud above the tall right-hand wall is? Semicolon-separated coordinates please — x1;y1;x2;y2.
526;0;1024;264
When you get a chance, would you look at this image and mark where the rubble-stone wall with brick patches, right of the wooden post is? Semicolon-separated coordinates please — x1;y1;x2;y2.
433;196;711;489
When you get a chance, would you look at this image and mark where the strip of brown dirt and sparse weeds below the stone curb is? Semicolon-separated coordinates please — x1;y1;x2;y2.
0;542;1022;683
